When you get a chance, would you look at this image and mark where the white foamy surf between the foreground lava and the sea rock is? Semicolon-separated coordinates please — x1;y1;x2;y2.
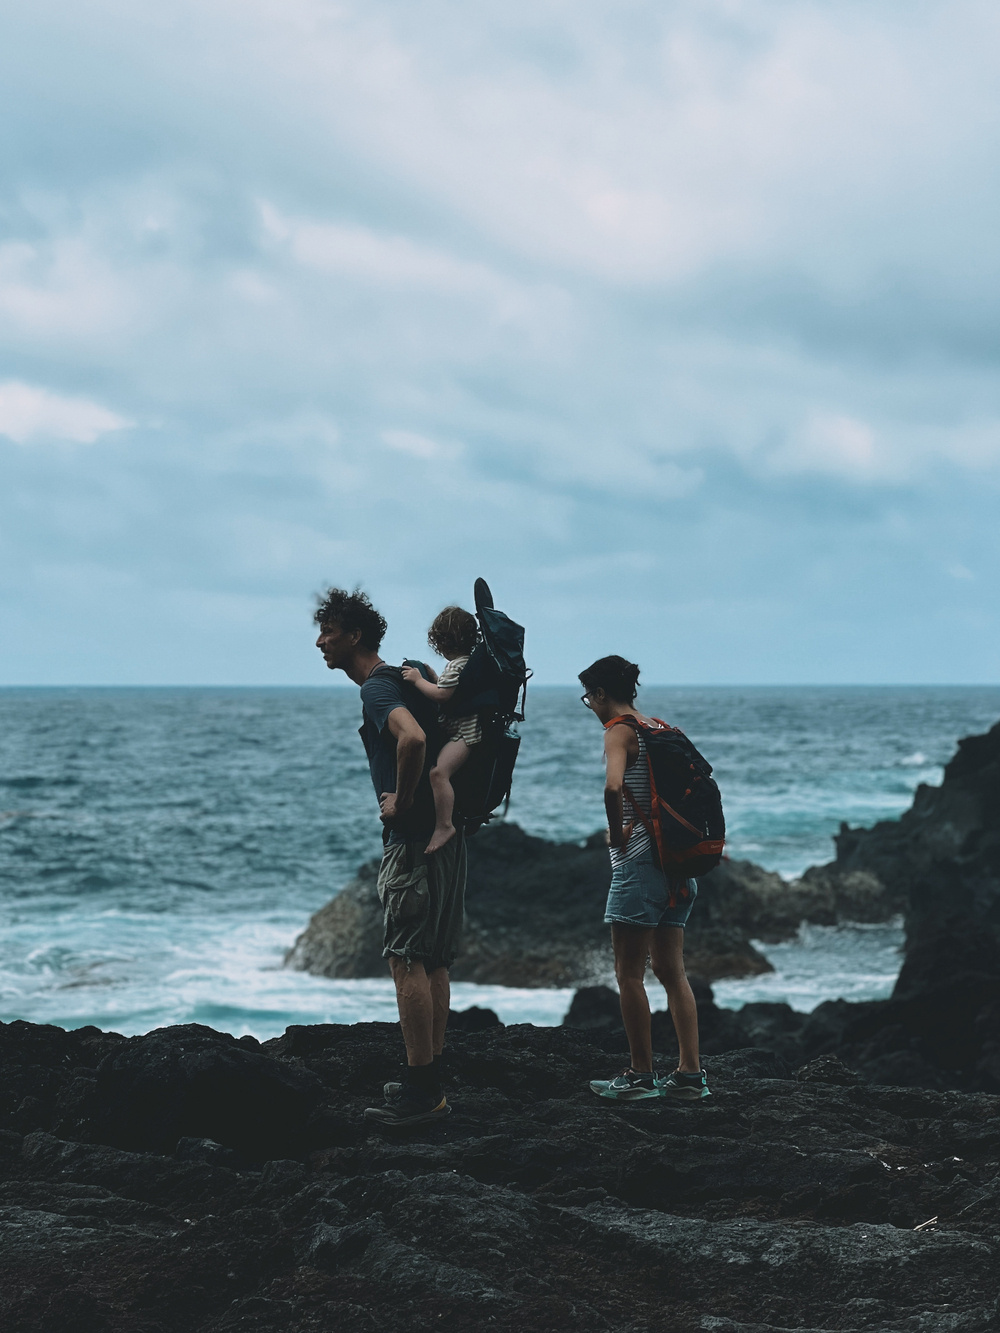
0;912;901;1040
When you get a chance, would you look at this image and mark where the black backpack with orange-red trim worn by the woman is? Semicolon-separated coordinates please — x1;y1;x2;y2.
607;713;725;878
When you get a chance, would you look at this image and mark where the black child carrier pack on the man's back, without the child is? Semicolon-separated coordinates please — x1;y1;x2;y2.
444;579;531;833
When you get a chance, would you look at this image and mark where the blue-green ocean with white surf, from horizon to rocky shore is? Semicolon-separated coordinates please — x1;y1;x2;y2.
0;686;1000;1038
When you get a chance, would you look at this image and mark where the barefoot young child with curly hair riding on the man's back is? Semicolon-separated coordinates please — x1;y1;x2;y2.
403;607;483;856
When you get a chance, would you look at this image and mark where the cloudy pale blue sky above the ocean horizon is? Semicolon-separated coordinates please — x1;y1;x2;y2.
0;0;1000;684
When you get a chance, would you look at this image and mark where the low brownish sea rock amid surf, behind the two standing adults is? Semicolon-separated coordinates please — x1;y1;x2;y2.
285;824;900;986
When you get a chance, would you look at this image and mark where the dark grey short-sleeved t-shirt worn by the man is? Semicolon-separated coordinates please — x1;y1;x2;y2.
360;664;441;842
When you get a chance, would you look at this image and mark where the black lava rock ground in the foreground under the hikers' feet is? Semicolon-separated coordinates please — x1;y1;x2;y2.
0;1016;1000;1333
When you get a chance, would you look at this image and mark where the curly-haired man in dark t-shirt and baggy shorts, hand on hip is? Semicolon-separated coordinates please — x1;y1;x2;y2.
315;588;465;1125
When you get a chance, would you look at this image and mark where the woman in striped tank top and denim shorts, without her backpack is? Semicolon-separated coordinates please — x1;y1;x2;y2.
580;656;709;1100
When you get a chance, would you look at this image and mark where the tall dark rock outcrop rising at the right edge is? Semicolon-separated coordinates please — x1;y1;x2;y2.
778;724;1000;1092
